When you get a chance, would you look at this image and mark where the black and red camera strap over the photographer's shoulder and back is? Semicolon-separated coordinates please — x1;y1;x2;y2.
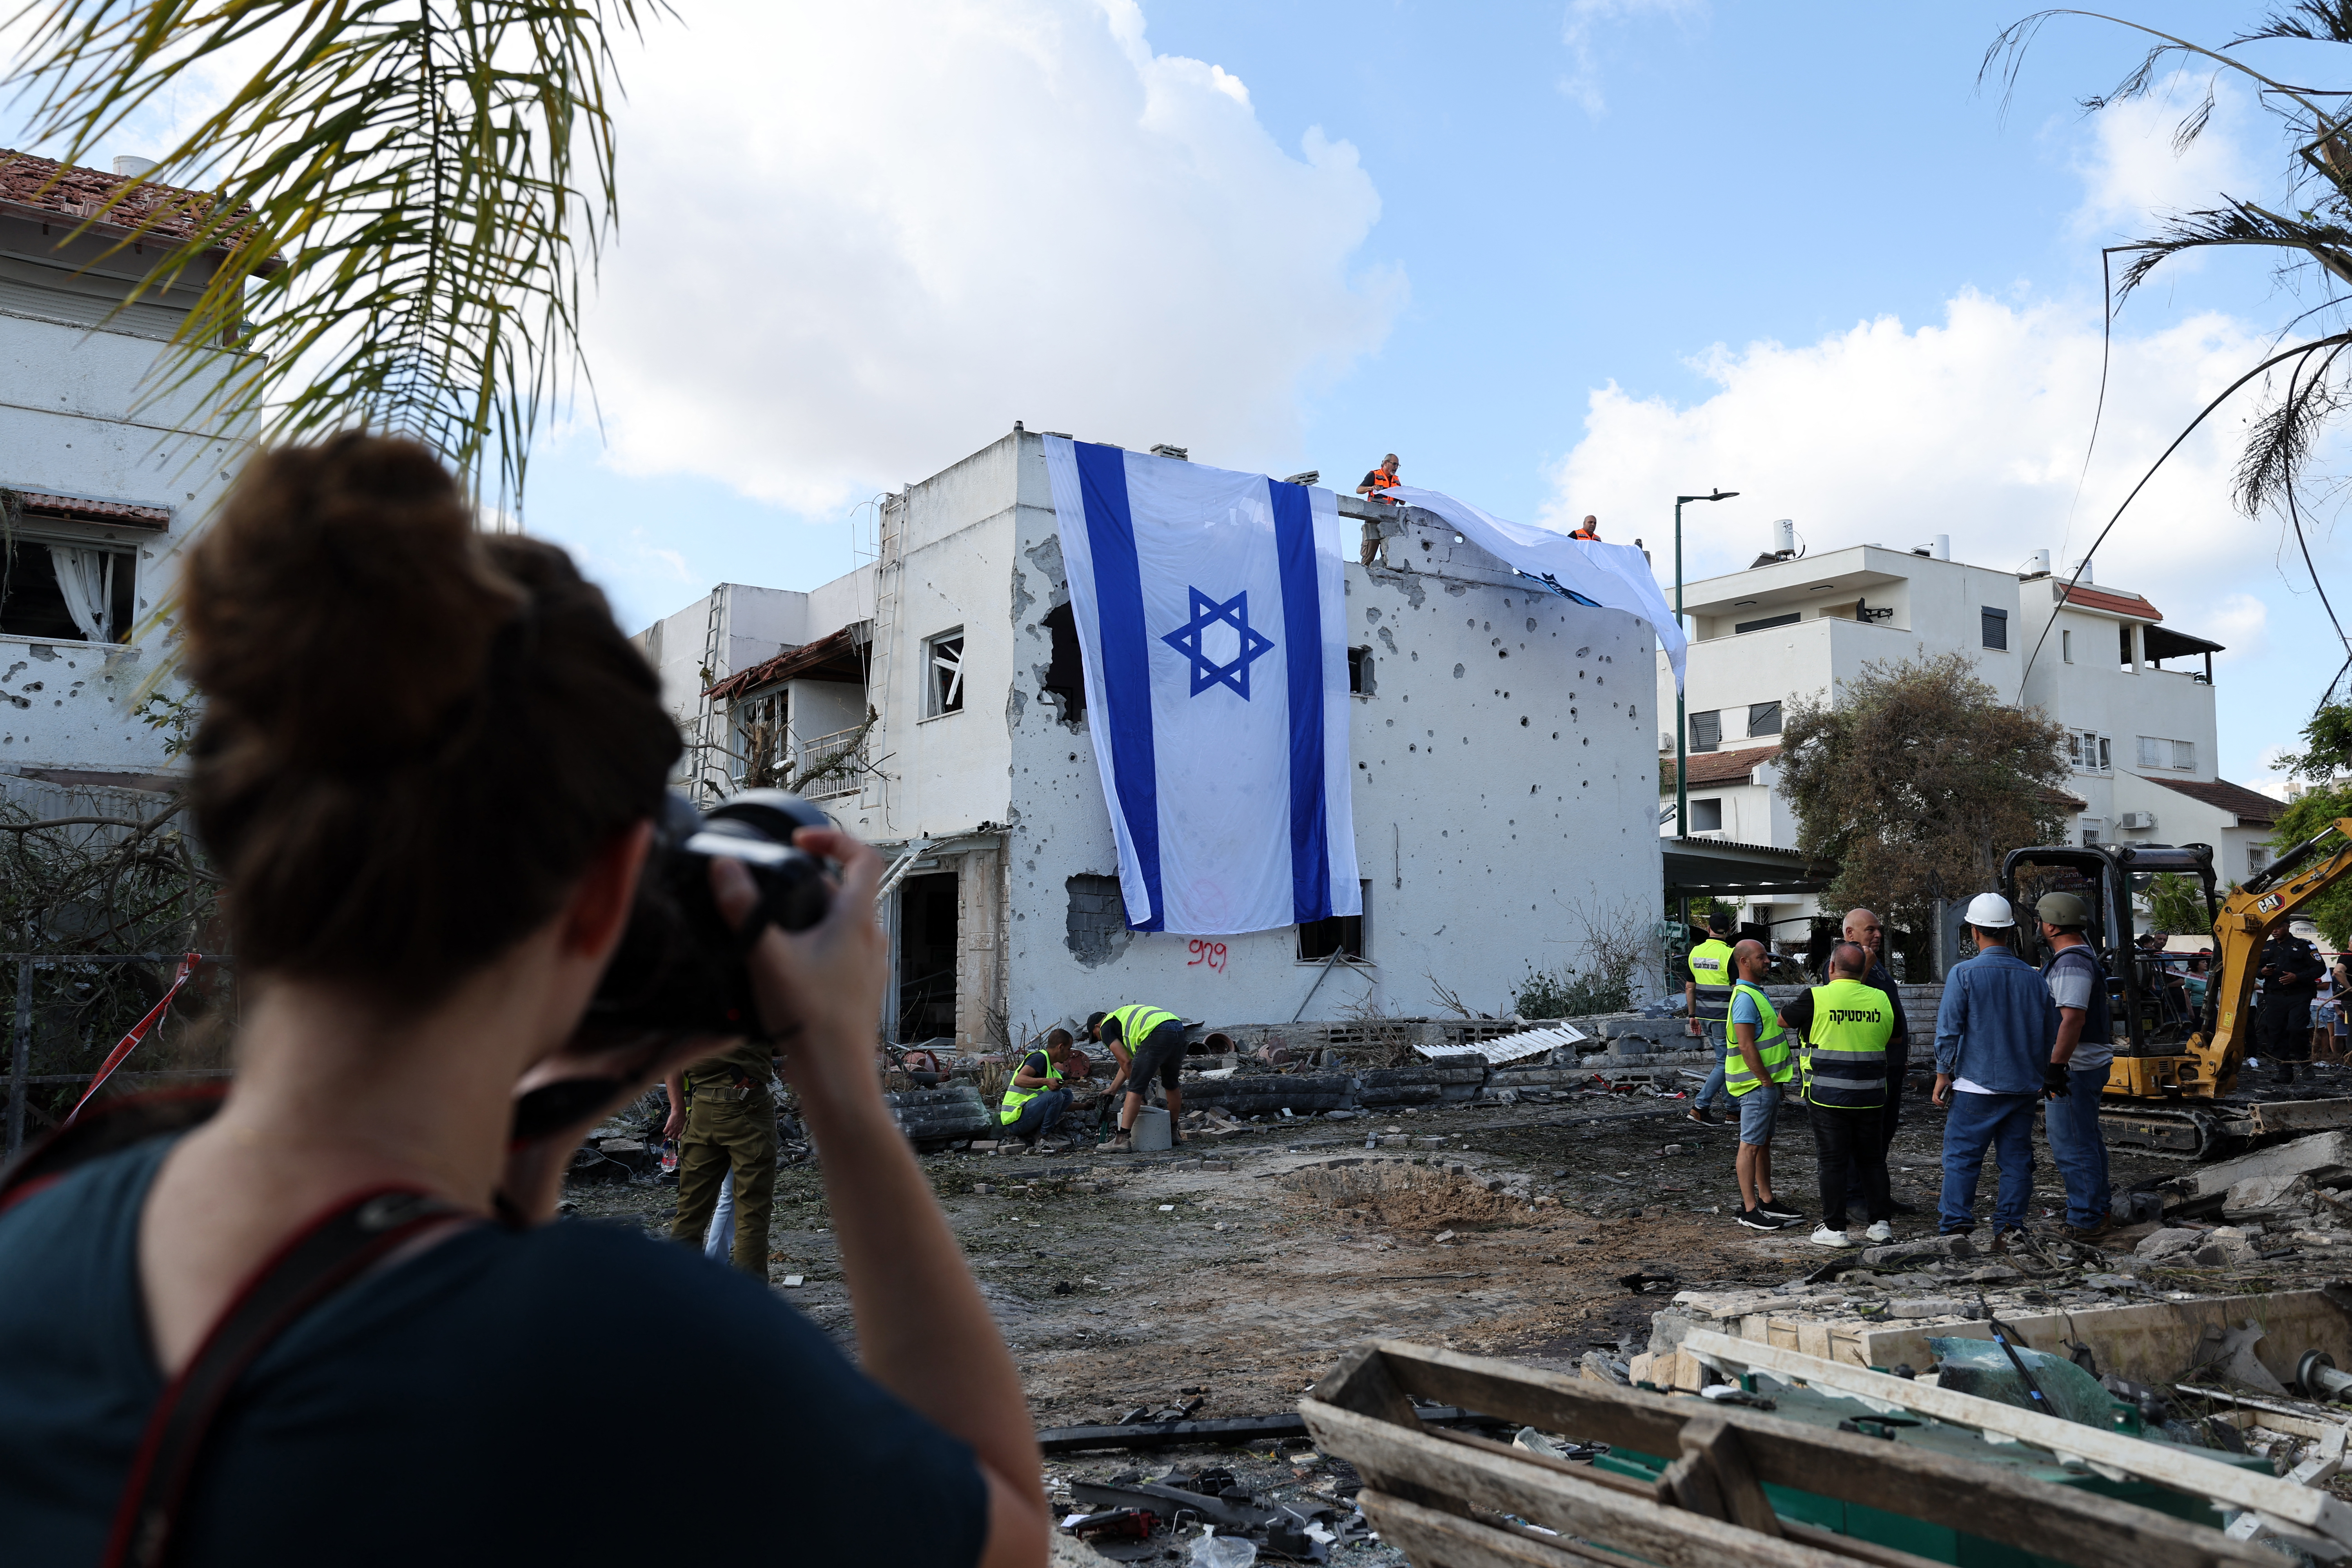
103;1187;480;1568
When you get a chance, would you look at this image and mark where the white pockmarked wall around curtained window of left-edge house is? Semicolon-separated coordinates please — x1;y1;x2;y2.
0;207;249;778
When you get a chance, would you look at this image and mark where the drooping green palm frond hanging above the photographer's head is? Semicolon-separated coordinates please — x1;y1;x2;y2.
9;0;666;505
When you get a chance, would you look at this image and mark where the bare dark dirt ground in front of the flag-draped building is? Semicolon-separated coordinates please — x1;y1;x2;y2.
569;1079;2180;1427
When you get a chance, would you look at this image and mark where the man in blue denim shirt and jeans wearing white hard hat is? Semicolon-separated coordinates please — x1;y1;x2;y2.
1936;893;2065;1250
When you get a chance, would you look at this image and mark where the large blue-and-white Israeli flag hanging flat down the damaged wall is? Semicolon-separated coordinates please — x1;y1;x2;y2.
1044;435;1364;936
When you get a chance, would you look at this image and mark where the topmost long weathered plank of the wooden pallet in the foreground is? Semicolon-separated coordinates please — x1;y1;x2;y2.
1378;1340;2277;1568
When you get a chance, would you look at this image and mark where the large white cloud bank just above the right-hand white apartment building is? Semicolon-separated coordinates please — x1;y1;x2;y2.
1545;292;2296;653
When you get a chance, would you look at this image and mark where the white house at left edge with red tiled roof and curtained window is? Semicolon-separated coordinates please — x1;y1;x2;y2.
0;158;249;795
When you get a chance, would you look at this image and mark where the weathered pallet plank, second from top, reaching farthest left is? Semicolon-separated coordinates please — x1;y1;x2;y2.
1298;1399;1853;1568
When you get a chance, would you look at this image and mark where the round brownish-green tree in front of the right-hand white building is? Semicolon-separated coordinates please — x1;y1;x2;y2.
1778;653;2070;931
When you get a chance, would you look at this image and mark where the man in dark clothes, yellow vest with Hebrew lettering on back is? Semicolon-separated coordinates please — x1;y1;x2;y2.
1783;943;1896;1246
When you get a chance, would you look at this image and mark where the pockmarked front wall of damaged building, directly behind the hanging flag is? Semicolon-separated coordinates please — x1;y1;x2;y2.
997;435;1663;1037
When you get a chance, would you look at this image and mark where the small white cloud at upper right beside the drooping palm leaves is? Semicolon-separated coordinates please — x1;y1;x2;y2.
2072;73;2277;242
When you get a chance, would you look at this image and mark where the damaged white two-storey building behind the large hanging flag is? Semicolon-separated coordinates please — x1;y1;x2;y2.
640;428;1661;1051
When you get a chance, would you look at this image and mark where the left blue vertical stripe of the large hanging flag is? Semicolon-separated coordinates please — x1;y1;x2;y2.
1070;442;1167;931
